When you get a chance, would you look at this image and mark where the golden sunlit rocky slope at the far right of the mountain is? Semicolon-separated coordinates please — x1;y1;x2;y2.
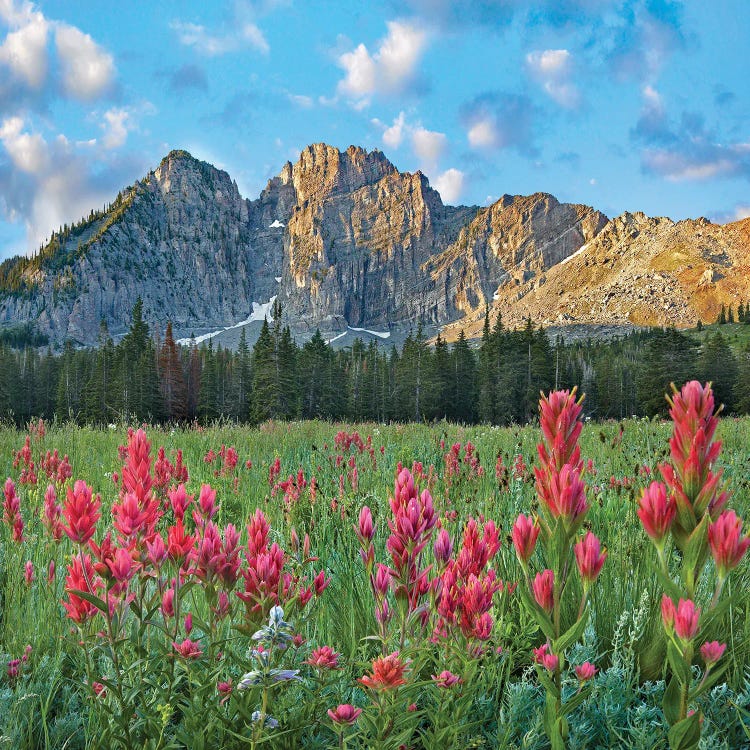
446;213;750;339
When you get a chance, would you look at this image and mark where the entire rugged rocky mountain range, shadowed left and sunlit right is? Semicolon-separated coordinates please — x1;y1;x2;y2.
0;144;750;345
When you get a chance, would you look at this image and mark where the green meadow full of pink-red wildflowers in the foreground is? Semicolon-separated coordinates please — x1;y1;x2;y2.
0;383;750;750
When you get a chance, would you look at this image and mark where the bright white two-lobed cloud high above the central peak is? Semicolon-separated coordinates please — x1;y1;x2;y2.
338;21;427;107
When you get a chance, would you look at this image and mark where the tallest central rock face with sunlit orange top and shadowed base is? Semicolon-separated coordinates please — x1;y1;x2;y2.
282;144;476;327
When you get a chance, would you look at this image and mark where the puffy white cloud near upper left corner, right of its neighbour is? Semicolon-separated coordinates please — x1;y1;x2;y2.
55;23;115;101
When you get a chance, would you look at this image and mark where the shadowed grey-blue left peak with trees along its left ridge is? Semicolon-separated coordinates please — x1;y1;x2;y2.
0;152;284;344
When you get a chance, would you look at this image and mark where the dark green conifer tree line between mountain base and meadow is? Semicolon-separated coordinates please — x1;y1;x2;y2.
0;300;750;425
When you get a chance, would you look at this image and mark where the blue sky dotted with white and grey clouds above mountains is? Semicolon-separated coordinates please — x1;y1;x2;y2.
0;0;750;258
